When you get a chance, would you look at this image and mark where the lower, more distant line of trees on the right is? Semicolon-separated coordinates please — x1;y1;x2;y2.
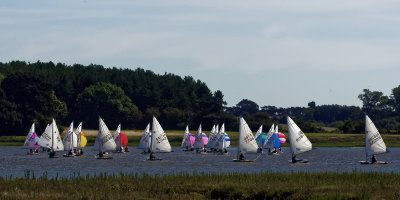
226;85;400;134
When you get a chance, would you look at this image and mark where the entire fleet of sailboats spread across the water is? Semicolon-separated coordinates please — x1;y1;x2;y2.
24;115;387;164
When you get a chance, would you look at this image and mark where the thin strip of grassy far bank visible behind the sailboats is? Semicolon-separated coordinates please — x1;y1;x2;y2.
4;130;400;147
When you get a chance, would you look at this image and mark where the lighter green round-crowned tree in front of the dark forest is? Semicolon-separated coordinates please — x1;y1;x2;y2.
76;82;142;128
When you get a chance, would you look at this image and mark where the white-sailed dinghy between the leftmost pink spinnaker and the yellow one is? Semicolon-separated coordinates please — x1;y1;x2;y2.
38;119;64;158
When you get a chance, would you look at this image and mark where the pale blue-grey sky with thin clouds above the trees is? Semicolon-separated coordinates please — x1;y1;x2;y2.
0;0;400;107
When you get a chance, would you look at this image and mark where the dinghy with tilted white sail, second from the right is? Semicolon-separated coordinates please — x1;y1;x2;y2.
287;116;312;163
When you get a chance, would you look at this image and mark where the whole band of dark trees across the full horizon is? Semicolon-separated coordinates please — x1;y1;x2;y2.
0;61;400;135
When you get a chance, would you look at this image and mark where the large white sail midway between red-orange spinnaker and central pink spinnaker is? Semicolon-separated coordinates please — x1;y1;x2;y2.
150;116;171;152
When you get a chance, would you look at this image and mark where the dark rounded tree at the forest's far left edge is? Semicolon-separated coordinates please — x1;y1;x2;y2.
0;72;67;135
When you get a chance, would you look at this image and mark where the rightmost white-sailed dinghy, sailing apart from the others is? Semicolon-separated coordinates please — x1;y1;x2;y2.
360;115;387;164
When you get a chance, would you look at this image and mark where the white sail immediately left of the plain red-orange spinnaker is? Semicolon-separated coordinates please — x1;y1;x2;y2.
94;117;117;151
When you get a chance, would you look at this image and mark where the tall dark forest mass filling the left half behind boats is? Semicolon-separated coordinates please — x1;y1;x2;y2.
0;61;247;135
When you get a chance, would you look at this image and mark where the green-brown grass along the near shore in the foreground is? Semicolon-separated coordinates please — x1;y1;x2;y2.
0;172;400;199
